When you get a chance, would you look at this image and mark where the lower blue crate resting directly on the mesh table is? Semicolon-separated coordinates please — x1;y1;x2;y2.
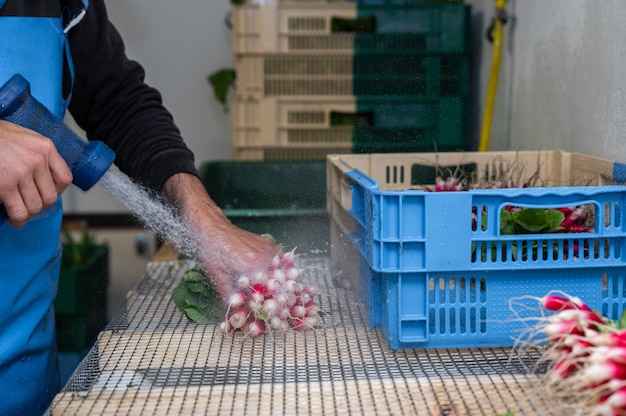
352;249;626;350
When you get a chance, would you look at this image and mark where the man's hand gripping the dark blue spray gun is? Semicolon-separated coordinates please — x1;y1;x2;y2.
0;120;72;227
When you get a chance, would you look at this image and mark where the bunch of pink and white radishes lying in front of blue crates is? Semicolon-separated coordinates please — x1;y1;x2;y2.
538;294;626;416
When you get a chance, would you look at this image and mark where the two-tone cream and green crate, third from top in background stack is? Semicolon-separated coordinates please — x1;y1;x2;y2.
233;96;468;153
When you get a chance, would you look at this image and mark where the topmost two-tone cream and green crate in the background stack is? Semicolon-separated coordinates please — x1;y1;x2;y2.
232;1;470;54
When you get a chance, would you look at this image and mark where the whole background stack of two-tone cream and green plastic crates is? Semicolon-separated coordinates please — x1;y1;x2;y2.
232;0;470;160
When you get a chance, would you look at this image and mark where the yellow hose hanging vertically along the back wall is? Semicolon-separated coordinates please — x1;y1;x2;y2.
478;0;506;152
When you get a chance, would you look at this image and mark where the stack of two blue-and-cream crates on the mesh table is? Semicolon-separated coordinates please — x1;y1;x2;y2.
328;151;626;349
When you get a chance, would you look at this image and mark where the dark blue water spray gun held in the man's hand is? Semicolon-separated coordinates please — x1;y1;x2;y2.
0;74;115;224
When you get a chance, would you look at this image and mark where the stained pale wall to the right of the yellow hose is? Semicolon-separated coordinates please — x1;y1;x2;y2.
509;0;626;161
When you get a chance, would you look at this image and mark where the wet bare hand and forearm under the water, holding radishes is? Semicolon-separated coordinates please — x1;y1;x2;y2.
162;174;280;301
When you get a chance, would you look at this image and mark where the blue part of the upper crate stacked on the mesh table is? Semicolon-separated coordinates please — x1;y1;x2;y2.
348;180;626;272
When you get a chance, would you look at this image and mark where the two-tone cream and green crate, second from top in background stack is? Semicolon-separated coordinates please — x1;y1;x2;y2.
236;54;470;97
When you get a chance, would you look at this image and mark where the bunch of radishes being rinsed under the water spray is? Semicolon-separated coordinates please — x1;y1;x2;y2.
220;251;321;338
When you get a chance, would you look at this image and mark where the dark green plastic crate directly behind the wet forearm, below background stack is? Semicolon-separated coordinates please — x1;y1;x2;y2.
200;160;330;253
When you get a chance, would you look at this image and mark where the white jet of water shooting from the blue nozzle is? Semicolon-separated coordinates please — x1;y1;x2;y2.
100;166;196;258
